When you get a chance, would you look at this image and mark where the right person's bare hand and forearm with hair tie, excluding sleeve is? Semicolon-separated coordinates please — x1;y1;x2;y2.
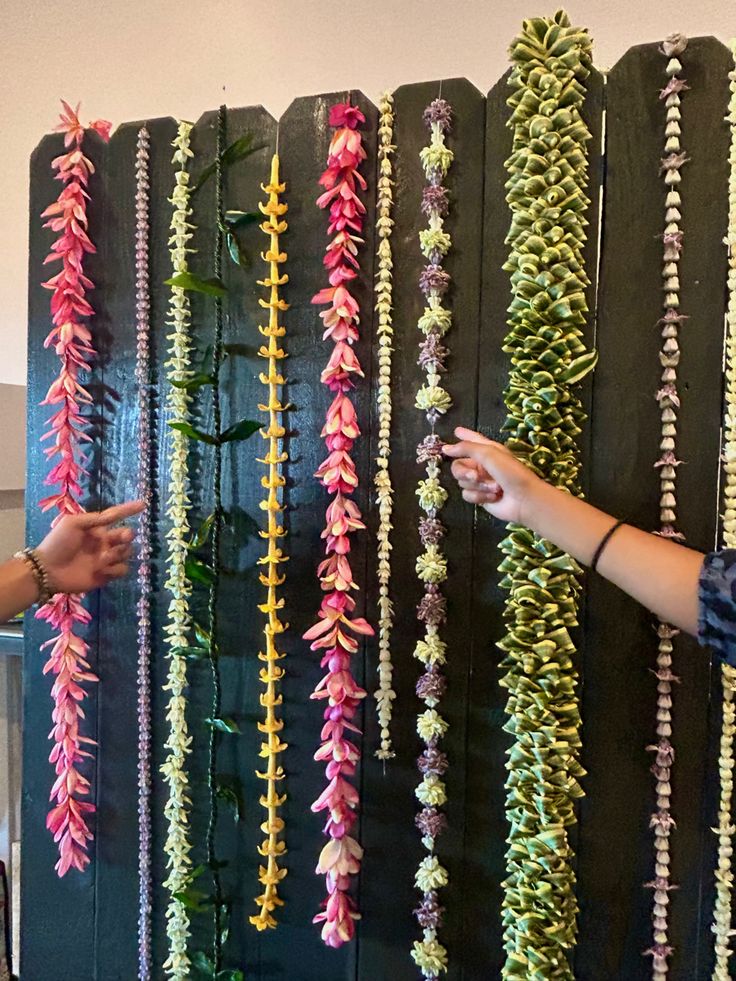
444;428;704;634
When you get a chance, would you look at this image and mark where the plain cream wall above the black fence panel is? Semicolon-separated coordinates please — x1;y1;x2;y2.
0;0;736;384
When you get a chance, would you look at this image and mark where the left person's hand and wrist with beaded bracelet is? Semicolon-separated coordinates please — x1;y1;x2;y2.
0;501;144;622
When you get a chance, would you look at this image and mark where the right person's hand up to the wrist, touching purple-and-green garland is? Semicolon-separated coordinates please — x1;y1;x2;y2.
443;426;544;524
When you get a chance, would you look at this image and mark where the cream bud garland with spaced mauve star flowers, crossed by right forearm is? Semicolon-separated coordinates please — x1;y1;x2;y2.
646;34;688;981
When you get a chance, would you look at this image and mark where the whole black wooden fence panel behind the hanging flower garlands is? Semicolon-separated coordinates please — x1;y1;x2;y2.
22;39;730;981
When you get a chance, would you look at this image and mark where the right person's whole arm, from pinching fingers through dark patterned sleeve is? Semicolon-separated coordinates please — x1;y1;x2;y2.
444;428;736;666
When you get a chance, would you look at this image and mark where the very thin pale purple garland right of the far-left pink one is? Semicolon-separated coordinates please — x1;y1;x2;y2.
135;126;152;981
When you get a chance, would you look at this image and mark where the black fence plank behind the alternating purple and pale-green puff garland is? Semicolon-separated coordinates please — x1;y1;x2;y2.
358;79;485;981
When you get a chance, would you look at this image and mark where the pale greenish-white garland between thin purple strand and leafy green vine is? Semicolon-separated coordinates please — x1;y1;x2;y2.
161;122;194;981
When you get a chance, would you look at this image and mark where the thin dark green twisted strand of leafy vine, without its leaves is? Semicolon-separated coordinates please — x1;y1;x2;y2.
207;105;227;973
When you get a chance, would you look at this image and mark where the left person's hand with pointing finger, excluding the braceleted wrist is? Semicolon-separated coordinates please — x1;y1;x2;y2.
36;501;145;593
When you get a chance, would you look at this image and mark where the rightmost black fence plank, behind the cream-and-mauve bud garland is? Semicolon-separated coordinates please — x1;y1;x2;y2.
576;38;730;981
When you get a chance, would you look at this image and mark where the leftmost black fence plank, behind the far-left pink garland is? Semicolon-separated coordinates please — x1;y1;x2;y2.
21;126;109;981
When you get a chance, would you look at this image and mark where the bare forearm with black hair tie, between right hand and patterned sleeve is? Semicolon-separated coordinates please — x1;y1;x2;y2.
524;482;703;634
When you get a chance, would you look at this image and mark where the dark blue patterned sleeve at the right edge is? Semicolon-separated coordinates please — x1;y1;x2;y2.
698;549;736;667
